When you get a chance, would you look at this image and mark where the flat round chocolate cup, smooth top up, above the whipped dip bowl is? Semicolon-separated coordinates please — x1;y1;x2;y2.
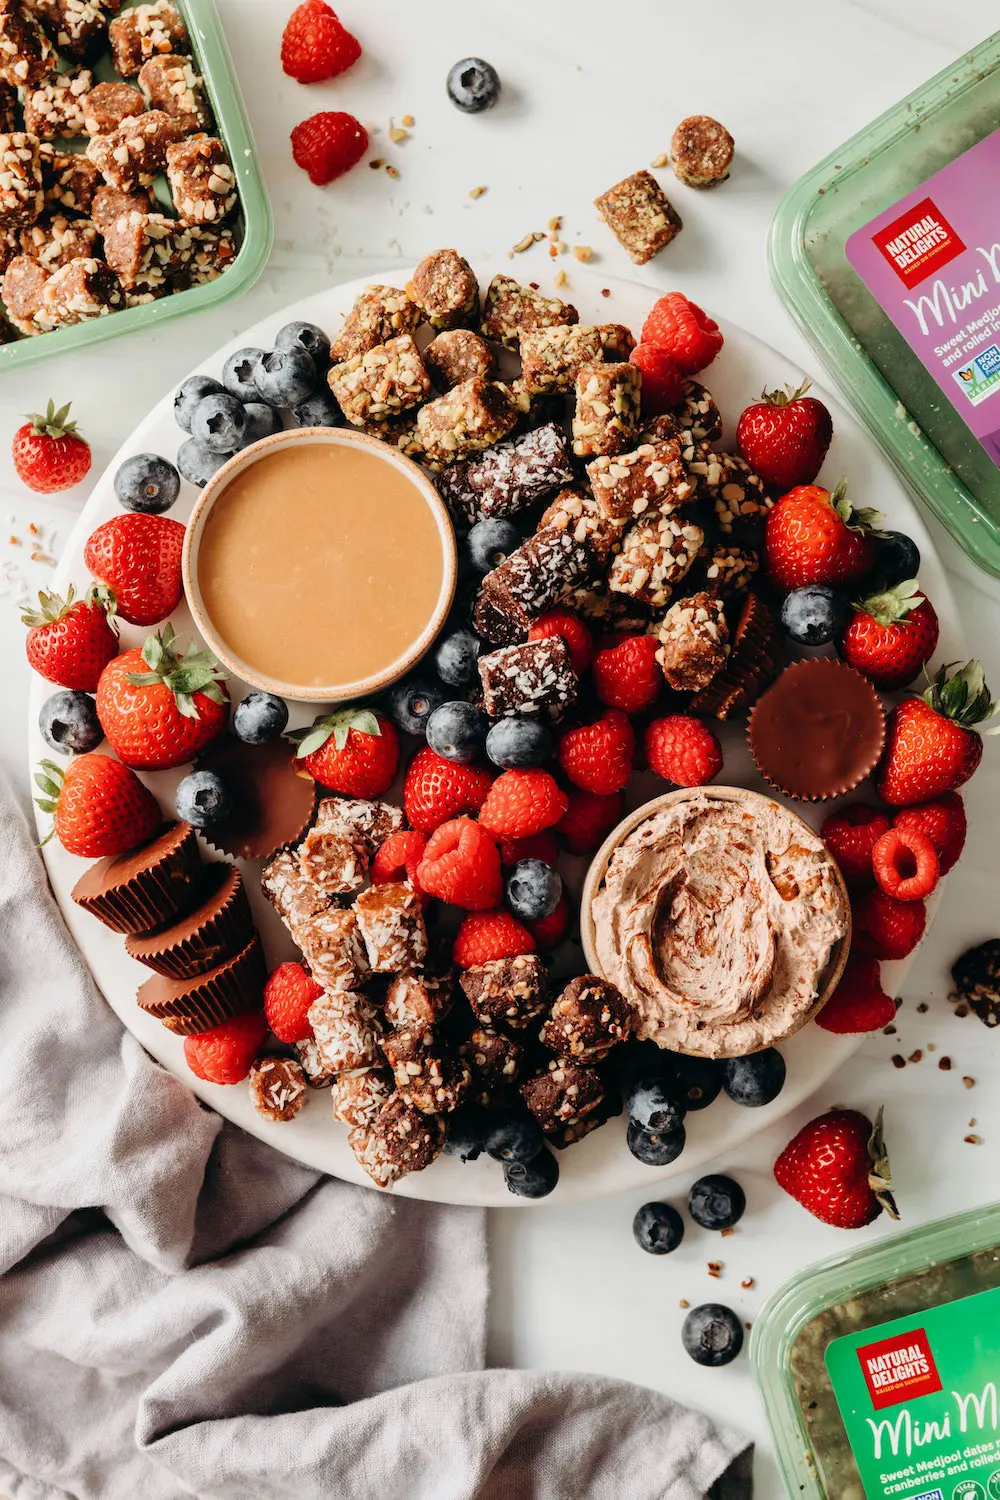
747;657;886;803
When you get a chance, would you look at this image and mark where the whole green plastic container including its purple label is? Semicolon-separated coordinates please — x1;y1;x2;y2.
769;33;1000;579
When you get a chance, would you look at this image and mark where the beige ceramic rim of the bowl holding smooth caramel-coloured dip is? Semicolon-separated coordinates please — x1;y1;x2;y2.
181;428;459;704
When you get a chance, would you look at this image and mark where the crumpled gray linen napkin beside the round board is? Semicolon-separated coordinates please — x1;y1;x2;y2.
0;779;750;1500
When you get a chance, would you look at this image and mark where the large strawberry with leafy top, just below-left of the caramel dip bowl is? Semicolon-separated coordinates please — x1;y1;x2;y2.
97;626;229;771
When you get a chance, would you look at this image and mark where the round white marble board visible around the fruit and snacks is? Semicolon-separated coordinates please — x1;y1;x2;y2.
28;263;969;1208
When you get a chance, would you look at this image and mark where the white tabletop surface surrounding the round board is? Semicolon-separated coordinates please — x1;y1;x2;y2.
0;0;1000;1500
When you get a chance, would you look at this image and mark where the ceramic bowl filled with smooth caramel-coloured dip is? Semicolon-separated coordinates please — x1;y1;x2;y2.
181;428;457;702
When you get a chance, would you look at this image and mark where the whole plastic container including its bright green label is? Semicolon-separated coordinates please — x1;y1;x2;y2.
750;1205;1000;1500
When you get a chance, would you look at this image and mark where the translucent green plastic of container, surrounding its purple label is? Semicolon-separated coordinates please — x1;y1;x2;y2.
769;33;1000;579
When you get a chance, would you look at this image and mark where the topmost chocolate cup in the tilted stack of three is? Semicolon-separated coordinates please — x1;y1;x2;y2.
73;824;202;933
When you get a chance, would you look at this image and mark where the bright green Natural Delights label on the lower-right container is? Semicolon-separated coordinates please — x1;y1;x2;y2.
826;1287;1000;1500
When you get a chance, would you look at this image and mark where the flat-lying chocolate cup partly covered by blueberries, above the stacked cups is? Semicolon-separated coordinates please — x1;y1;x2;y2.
198;735;318;860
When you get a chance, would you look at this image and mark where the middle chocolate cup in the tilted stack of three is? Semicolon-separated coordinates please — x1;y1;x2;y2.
124;864;253;980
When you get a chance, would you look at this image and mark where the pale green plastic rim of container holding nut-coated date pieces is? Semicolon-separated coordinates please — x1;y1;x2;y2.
0;0;274;372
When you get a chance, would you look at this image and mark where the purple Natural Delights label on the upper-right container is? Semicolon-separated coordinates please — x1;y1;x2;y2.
847;131;1000;471
